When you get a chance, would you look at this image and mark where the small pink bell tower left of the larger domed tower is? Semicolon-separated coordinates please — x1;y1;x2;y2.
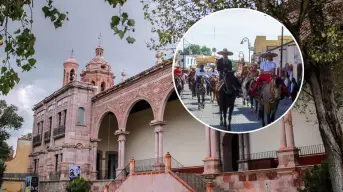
63;50;79;86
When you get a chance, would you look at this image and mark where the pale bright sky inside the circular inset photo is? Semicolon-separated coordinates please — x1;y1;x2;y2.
178;9;291;61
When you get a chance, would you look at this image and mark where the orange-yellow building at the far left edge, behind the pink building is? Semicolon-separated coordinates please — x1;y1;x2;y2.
2;138;32;192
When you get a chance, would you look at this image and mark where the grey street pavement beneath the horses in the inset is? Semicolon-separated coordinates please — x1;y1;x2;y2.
181;85;292;132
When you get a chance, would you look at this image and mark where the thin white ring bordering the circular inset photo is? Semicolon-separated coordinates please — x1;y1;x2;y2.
172;8;305;134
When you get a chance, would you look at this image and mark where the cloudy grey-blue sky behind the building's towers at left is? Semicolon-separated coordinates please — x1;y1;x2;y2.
0;0;156;153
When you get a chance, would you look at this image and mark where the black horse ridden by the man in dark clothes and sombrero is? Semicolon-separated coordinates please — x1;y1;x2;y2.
217;71;240;131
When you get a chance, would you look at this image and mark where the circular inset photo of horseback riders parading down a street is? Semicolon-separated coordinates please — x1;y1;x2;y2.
173;9;304;133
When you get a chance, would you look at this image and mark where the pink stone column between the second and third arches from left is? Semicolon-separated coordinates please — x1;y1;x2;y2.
150;120;166;167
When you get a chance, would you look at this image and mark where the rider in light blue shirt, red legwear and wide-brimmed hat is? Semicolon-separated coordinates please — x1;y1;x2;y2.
251;52;288;97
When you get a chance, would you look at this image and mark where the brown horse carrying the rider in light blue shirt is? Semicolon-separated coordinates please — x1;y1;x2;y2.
258;77;282;127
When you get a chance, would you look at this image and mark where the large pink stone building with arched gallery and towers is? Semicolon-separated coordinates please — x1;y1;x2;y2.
29;46;325;191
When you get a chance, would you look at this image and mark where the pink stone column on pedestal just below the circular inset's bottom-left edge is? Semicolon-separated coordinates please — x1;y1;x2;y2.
203;127;220;176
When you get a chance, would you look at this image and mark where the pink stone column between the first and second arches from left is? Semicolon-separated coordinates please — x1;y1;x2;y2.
114;129;130;179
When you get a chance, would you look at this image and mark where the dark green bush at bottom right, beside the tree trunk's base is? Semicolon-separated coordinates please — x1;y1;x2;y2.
299;161;332;192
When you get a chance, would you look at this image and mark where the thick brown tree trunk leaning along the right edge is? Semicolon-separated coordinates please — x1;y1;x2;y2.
306;67;343;192
